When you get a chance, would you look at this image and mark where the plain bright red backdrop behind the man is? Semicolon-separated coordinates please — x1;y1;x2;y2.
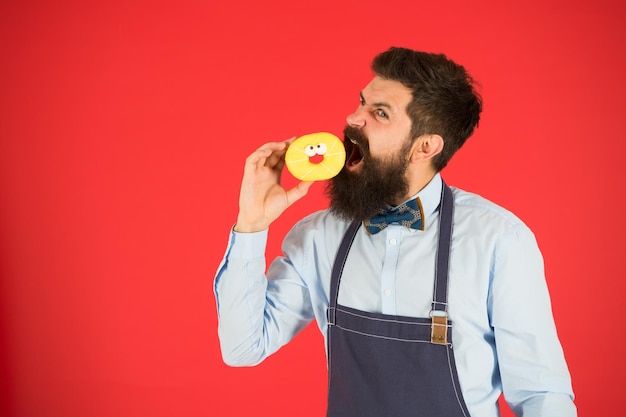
0;0;626;417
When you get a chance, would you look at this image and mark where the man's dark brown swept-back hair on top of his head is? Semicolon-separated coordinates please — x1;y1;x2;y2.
372;47;482;171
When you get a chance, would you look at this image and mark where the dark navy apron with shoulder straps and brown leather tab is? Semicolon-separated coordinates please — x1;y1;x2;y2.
327;184;470;417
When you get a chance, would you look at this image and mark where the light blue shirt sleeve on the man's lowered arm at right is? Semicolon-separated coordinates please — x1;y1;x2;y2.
490;225;576;417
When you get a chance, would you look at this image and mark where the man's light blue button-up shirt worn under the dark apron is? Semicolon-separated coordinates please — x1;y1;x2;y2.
214;175;576;417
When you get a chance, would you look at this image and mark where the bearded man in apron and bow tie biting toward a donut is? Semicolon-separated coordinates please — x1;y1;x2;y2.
214;48;576;417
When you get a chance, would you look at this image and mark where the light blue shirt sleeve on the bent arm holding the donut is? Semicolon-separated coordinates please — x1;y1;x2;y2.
214;226;313;366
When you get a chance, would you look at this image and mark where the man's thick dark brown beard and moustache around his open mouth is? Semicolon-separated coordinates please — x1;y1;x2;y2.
326;126;411;221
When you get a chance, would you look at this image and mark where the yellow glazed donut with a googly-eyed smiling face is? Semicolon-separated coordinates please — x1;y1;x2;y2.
285;132;346;181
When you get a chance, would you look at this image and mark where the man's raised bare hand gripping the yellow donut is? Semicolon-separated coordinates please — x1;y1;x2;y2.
234;137;313;233
